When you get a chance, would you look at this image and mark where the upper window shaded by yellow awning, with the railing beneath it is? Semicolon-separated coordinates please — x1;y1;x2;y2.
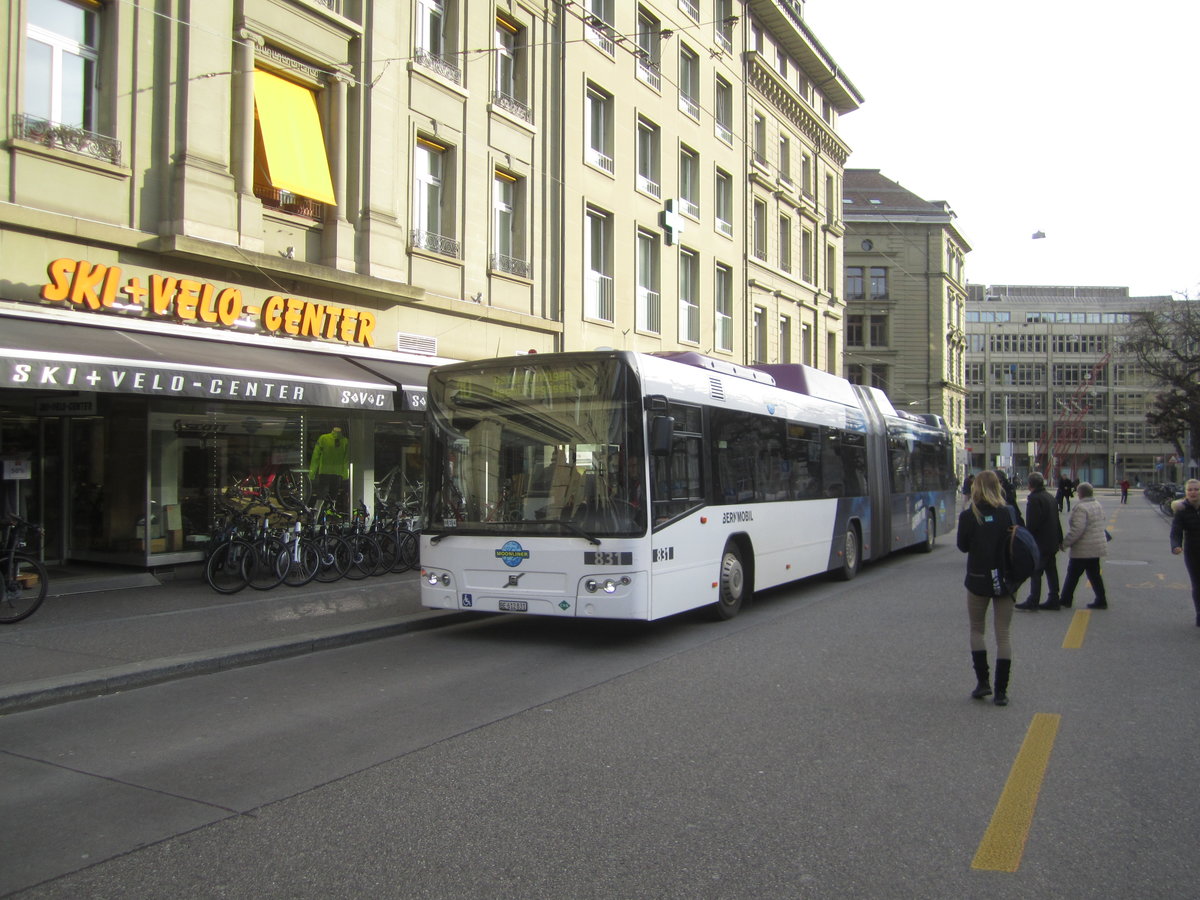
253;70;336;218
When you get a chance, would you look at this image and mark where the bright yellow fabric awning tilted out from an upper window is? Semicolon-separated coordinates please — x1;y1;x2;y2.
254;70;336;204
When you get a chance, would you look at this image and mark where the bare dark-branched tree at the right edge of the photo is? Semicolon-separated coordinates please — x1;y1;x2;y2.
1121;294;1200;468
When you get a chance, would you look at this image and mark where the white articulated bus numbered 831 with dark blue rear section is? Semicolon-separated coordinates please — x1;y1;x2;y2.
421;350;956;619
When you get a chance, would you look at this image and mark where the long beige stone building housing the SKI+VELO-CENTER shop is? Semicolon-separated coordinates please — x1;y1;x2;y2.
0;0;860;566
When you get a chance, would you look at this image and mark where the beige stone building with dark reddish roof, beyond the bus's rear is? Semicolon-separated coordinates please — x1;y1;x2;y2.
842;169;971;468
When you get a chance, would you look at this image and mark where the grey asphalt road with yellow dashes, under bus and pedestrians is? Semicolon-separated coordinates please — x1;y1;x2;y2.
0;498;1200;898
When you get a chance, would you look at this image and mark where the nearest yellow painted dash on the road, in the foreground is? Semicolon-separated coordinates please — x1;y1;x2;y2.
971;713;1062;872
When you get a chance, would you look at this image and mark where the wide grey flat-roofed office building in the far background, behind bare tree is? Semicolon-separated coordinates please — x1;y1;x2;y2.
966;284;1177;486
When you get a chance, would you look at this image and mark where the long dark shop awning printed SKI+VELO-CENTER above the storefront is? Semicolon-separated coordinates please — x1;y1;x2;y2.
0;317;403;410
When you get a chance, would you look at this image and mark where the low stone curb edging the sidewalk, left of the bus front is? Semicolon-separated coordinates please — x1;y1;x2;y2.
0;611;480;715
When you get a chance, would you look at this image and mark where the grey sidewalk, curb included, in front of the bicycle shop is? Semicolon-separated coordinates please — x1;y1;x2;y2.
0;565;472;715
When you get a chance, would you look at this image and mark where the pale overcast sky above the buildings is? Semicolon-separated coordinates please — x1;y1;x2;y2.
804;0;1200;296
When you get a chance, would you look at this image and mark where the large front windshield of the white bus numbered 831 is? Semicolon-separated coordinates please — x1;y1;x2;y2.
425;354;646;541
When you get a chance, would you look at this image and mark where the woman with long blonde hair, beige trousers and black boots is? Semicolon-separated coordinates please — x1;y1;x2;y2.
958;469;1016;707
